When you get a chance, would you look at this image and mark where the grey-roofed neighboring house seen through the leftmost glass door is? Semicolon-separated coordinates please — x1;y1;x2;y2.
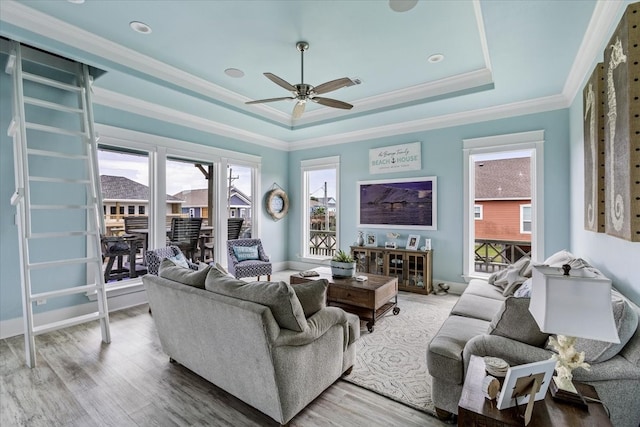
100;175;183;231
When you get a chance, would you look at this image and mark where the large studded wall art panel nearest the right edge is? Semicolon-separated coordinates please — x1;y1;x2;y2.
604;3;640;242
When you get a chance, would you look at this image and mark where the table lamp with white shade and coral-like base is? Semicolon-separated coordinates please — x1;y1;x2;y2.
529;265;620;406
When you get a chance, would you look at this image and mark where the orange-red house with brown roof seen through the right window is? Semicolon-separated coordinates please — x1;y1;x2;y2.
474;157;531;242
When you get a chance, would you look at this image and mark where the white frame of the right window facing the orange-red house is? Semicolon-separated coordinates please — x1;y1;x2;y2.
462;130;545;281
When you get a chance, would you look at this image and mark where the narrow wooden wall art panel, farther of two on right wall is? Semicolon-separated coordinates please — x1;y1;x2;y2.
582;62;605;233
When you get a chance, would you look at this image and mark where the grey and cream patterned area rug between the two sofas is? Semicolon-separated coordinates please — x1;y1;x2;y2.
342;293;458;415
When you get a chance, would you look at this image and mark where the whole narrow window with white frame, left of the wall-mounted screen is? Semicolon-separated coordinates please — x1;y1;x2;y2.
301;157;340;259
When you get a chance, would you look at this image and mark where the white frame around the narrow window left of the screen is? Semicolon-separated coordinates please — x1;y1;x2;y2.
300;156;340;261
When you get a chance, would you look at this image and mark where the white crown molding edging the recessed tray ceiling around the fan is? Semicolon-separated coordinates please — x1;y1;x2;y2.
0;0;493;130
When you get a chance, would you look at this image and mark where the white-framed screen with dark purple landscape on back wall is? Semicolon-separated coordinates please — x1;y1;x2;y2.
358;176;438;230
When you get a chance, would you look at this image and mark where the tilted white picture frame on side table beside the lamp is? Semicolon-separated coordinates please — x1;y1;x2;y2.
497;359;556;410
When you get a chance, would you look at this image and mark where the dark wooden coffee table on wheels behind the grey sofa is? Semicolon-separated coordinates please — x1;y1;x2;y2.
289;267;400;332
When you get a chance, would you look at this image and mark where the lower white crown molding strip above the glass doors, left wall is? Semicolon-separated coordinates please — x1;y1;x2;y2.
92;87;289;150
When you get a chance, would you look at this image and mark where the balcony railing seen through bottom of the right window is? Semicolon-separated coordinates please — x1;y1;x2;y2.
475;239;531;273
